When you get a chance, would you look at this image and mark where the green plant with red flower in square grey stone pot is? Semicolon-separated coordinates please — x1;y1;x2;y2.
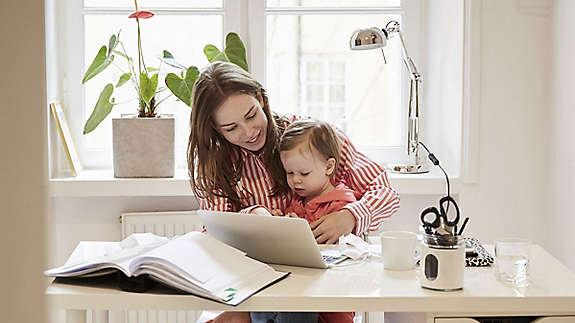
82;0;248;177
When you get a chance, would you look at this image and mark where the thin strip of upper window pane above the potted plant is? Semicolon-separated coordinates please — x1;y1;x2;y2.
84;0;222;9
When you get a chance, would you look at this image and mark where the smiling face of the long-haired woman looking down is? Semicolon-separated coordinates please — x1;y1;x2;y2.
212;93;268;152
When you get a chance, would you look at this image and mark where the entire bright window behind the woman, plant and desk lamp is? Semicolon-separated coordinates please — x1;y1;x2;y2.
49;0;417;172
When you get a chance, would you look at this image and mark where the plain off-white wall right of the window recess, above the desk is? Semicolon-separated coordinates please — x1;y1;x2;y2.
461;0;552;248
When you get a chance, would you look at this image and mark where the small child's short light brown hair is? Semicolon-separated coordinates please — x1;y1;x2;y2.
279;119;341;176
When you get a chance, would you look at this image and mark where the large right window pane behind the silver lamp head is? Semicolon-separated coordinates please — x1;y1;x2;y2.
266;14;407;147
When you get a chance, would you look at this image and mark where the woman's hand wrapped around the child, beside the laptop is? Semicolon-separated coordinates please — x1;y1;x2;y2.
310;209;355;244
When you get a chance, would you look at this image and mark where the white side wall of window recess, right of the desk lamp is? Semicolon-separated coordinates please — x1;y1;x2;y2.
420;0;464;177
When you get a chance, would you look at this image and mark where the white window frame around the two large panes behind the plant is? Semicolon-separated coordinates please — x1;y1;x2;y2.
52;0;423;170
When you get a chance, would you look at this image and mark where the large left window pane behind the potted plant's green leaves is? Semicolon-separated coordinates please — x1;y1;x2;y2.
84;15;223;165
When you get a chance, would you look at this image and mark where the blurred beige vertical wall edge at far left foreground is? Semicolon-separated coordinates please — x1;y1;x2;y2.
0;0;47;323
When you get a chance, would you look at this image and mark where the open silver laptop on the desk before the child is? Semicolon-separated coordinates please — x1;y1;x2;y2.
198;210;347;268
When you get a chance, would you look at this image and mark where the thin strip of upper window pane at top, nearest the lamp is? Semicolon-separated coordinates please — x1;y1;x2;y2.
267;0;401;8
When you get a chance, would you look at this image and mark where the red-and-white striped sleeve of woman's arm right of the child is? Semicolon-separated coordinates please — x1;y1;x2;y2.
338;131;399;235
